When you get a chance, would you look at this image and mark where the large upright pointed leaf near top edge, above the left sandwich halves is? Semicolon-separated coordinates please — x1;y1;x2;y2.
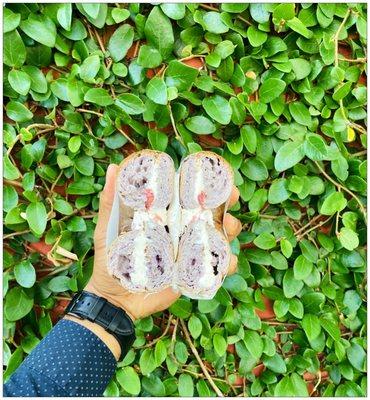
144;6;175;60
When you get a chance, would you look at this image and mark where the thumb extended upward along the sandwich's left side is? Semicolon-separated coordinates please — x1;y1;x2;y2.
95;164;118;238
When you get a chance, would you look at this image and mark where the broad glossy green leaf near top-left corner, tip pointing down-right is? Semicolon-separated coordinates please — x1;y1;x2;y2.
20;13;57;47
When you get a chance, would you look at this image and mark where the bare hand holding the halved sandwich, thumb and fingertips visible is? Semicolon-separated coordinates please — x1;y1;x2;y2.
85;164;241;320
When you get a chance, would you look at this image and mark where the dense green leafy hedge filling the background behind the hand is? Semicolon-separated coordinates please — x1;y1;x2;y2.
3;3;367;396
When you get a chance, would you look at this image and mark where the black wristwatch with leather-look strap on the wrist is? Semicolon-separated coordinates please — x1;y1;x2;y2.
65;290;135;360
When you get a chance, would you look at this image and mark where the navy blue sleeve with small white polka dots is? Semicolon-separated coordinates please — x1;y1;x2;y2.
4;320;117;397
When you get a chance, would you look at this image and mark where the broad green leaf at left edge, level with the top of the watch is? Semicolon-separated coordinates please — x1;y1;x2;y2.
4;287;33;321
